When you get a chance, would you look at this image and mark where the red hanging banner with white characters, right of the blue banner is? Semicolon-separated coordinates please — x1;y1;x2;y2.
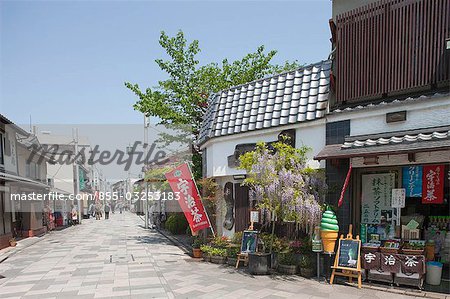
422;165;445;204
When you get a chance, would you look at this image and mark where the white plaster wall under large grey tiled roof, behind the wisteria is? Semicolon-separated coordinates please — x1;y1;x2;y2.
203;120;325;177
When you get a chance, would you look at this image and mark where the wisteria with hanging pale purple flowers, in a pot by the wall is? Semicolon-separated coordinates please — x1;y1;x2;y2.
239;141;322;273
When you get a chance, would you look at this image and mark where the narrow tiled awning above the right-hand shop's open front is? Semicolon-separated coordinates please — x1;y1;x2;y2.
314;126;450;160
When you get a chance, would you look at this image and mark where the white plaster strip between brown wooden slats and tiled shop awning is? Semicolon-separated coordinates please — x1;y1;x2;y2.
327;96;450;136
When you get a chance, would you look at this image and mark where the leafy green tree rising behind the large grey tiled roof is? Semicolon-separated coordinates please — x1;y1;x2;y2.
125;31;300;178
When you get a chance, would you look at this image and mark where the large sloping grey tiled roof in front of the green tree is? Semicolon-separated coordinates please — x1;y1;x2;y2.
199;60;331;144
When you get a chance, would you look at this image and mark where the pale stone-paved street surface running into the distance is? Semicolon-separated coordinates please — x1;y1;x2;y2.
0;213;444;299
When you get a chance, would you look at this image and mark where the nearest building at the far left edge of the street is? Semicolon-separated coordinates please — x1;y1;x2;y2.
0;115;50;248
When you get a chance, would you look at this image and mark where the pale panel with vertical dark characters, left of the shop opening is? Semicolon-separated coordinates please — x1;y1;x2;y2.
361;173;395;224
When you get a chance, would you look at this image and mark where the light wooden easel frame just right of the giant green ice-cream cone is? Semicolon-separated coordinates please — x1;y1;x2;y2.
330;224;362;289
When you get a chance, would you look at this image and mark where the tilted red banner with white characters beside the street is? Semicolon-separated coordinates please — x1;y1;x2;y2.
166;163;211;232
